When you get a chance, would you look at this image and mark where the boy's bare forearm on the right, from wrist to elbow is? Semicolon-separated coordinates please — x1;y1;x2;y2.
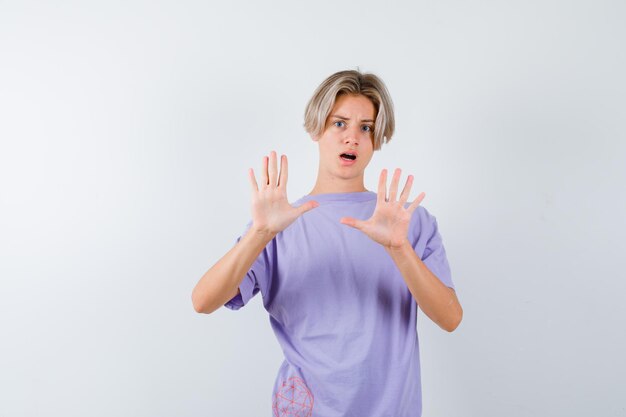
385;240;463;332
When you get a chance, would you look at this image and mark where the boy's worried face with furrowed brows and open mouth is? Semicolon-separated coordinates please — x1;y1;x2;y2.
313;94;376;179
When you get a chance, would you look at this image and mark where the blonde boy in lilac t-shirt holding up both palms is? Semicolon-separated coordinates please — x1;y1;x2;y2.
192;71;463;417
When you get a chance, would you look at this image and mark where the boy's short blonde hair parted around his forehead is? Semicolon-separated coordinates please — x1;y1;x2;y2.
304;70;395;150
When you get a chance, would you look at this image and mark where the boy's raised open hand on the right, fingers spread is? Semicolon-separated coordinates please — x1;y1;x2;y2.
340;168;426;249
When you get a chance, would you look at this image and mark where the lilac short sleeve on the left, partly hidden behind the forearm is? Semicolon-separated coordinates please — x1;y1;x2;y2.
224;221;275;310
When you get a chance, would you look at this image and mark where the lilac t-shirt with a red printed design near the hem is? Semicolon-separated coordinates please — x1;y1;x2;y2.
225;191;454;417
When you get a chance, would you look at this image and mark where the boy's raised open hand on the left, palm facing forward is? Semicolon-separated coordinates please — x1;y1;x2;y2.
248;151;319;235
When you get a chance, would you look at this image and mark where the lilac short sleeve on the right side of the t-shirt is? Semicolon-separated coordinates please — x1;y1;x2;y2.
412;206;454;289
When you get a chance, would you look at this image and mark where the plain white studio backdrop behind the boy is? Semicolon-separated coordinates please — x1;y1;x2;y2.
0;0;626;417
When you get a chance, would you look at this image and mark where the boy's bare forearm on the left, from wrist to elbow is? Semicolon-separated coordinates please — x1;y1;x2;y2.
191;228;275;314
